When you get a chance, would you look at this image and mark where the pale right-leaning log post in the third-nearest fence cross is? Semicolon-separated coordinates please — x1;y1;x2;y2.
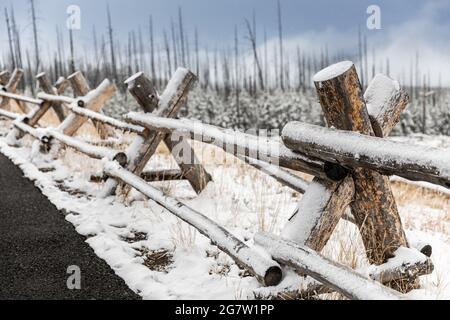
58;80;116;136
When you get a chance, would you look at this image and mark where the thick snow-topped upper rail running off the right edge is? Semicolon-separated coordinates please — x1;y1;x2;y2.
283;122;450;188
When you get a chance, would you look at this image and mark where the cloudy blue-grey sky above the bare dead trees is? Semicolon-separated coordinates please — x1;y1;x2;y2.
0;0;450;84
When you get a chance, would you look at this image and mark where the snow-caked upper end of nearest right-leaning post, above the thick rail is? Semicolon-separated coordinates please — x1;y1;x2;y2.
364;74;409;138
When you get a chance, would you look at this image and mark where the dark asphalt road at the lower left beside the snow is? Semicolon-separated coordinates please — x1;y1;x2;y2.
0;153;140;300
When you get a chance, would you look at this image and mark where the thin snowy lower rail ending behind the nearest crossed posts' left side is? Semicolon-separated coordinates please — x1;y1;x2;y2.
245;157;309;193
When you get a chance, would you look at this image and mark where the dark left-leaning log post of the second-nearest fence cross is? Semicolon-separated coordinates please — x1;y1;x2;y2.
125;73;211;194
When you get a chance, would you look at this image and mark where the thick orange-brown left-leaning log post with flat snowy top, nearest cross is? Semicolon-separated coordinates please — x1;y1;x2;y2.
314;61;408;264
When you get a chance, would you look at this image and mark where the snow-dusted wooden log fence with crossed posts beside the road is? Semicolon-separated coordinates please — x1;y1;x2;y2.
0;62;442;299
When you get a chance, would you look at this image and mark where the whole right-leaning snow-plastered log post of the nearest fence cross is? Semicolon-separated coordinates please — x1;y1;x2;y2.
283;74;409;252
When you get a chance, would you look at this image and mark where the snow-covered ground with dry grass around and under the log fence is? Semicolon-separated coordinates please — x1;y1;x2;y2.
0;120;450;299
